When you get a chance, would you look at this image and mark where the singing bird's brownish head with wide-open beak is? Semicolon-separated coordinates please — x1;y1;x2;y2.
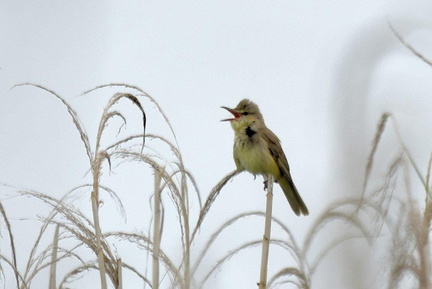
222;99;264;130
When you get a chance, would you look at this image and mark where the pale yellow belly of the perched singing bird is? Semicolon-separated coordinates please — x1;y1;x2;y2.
234;144;279;178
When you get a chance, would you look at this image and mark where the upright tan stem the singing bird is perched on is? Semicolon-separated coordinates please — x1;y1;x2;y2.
259;175;273;289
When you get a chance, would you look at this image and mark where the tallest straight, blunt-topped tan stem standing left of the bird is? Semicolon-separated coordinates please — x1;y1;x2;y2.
152;170;163;289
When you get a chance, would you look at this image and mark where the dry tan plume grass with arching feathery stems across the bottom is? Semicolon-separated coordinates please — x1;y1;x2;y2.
0;79;432;289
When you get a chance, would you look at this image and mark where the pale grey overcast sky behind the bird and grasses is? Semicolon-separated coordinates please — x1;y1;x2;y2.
0;0;432;288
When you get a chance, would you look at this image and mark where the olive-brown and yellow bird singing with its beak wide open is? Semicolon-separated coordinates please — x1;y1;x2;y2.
221;99;309;216
